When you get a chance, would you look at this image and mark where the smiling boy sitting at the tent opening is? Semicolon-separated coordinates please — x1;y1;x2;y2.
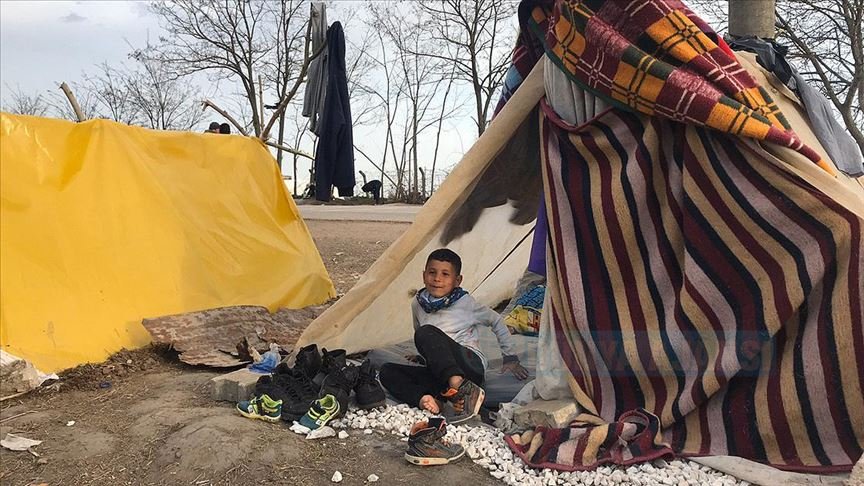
379;248;528;424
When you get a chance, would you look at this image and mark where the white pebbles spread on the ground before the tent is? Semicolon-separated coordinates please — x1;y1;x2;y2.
330;404;748;486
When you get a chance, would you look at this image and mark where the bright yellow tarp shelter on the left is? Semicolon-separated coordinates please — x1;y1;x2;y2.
0;113;335;372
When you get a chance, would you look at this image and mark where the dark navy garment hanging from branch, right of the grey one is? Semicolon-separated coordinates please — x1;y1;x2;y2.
315;22;357;201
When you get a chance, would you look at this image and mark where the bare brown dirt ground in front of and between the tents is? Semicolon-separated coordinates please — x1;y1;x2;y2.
0;221;497;486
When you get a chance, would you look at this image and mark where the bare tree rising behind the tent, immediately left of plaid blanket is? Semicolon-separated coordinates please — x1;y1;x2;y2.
414;0;517;136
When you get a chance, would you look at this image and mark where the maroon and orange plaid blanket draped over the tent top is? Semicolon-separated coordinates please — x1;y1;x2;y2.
520;0;835;173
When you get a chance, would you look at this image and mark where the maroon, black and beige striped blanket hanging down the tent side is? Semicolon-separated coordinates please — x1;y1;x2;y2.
525;104;864;472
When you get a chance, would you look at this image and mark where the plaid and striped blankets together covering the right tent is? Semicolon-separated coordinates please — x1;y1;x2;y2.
505;0;864;472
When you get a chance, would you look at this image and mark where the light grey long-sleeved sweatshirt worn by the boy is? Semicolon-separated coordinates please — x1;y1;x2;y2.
411;294;516;369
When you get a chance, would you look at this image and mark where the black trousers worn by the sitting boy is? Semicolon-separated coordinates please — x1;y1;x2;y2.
378;325;484;407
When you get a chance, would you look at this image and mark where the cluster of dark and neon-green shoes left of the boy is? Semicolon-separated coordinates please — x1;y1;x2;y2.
237;344;386;430
